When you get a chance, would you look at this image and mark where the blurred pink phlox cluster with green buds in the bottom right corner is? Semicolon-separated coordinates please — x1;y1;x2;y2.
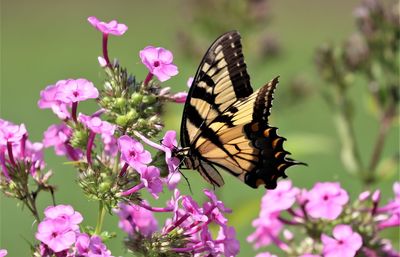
248;181;400;257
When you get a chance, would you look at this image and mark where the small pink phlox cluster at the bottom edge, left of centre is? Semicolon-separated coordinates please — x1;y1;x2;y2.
35;205;112;257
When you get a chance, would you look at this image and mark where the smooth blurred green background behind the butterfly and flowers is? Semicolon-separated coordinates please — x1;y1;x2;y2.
0;0;399;257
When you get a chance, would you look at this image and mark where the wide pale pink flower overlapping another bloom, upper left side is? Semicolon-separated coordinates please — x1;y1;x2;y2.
55;79;99;104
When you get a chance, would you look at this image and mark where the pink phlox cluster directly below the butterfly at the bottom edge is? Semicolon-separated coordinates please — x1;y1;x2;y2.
116;189;239;257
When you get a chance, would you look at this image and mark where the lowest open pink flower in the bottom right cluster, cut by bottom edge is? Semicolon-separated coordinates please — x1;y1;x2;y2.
321;225;362;257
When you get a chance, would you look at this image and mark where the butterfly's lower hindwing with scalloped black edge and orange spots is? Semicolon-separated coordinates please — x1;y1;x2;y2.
195;78;300;189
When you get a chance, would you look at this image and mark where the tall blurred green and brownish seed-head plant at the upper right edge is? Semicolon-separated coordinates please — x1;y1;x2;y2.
315;0;400;186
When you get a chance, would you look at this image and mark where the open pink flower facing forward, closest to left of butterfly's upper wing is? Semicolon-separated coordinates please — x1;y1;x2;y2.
139;46;178;82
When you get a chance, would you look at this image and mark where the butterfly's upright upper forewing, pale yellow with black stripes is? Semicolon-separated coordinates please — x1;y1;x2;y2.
181;31;253;147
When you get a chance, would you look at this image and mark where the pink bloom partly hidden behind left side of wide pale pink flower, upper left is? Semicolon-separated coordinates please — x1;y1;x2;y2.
38;80;71;120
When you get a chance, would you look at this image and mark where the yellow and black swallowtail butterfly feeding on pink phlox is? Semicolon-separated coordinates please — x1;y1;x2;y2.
174;31;304;189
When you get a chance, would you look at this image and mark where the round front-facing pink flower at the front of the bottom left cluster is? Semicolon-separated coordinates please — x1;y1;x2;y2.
36;218;76;252
